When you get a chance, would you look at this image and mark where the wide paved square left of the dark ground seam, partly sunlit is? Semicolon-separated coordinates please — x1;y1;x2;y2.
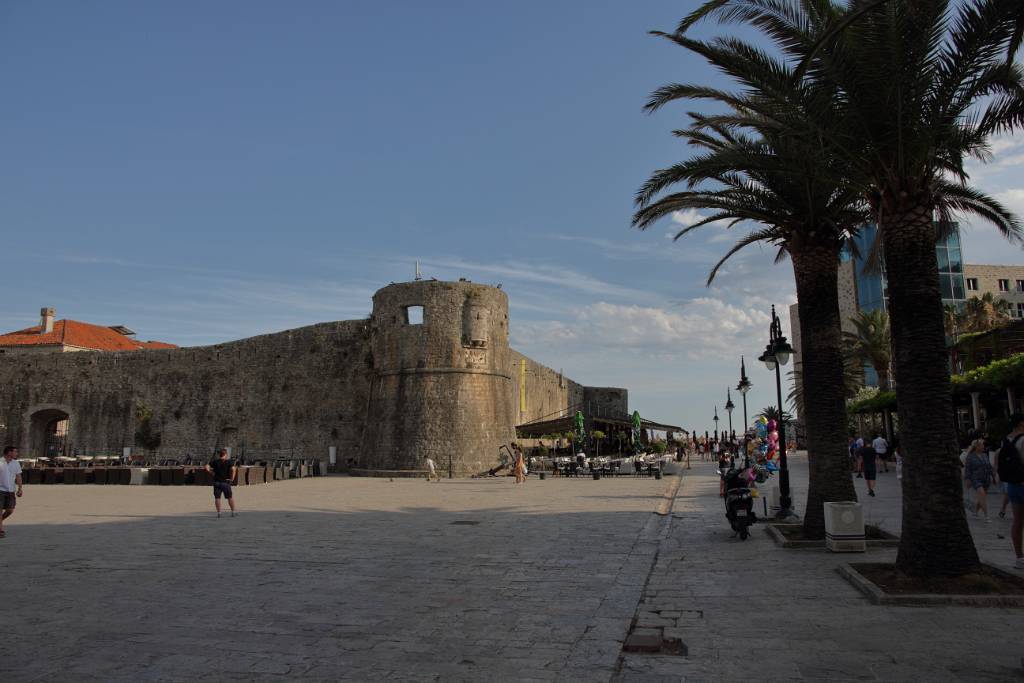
0;477;677;683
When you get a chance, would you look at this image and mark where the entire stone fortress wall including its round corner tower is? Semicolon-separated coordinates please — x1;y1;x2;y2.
0;281;627;473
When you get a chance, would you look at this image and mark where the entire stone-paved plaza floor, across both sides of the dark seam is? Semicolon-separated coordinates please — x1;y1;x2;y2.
0;456;1024;681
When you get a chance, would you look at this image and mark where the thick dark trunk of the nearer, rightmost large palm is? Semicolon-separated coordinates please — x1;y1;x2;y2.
880;200;978;575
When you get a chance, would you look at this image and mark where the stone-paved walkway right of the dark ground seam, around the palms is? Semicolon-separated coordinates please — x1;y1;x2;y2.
615;456;1024;682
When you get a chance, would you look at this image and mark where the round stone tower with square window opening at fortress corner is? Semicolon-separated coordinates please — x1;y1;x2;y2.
361;281;515;474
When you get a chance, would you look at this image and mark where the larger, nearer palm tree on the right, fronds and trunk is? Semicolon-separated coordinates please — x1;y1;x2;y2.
681;0;1024;575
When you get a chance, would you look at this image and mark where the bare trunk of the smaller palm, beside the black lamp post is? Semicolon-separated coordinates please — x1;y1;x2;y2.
791;247;856;539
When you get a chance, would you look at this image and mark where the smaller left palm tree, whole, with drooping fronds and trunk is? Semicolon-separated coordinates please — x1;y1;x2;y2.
633;17;867;539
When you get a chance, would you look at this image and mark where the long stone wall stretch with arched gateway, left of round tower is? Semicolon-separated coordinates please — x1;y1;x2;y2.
0;321;371;458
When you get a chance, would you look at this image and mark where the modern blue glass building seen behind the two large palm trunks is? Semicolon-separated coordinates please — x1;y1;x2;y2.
843;223;967;386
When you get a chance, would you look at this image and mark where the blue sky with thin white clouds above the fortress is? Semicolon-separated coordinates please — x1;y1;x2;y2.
0;0;1024;430
